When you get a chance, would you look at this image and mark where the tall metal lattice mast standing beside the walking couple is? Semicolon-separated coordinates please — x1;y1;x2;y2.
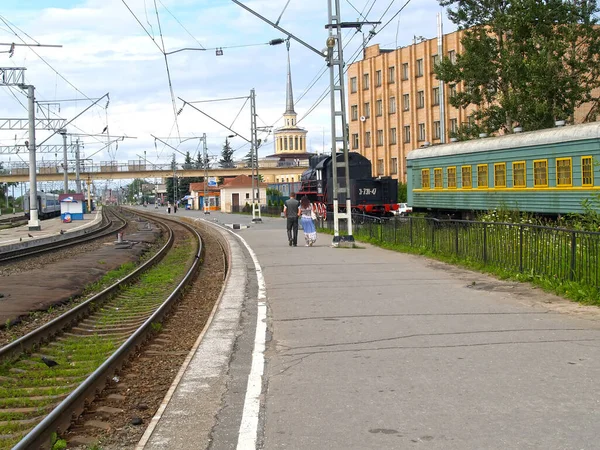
327;0;354;247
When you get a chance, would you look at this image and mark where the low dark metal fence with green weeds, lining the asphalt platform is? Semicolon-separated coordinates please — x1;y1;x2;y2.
322;215;600;288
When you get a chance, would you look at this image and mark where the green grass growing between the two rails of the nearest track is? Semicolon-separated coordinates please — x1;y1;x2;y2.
0;239;195;449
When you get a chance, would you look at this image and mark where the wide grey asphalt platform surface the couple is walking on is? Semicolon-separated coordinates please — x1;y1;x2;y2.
136;209;600;450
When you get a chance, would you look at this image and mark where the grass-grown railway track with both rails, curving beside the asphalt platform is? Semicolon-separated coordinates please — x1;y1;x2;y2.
0;213;202;449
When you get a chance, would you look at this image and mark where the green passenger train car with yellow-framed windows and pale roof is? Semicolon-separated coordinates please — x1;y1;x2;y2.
406;122;600;217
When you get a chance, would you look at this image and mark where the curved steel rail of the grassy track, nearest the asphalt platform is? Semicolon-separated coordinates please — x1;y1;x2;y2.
13;212;202;450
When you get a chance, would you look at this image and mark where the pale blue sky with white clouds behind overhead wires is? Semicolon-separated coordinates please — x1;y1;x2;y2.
0;0;453;185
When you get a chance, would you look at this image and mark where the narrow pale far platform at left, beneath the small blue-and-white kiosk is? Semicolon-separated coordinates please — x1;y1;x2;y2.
0;209;102;252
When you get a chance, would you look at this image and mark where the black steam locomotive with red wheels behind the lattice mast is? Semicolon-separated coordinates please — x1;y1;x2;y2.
296;152;398;216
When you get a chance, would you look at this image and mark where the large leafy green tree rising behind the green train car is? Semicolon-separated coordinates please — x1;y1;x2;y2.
435;0;600;139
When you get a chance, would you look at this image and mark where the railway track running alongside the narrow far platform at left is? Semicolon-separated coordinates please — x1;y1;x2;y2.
0;208;127;263
